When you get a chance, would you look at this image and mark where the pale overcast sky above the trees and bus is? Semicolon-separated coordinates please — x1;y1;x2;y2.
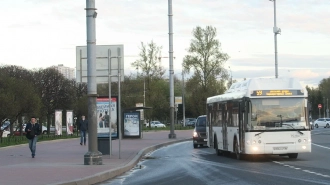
0;0;330;86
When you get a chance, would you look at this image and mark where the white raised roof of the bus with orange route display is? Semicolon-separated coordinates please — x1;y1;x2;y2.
207;78;307;103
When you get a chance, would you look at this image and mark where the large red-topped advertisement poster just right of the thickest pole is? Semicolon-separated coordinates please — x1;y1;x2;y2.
96;97;118;137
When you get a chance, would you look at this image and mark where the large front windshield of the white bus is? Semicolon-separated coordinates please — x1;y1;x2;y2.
247;98;308;130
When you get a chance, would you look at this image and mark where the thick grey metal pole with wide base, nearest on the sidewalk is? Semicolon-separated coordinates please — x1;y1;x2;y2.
84;0;102;165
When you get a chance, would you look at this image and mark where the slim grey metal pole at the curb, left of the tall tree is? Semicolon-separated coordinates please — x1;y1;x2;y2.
168;0;176;139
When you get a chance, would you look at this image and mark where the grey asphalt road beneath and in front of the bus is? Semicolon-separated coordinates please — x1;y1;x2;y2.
100;128;330;185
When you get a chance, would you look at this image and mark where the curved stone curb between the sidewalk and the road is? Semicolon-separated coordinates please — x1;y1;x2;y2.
52;138;191;185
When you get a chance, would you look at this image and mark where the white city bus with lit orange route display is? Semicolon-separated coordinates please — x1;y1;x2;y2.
206;78;311;159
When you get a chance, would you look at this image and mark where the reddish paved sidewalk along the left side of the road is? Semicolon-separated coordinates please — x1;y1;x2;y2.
0;130;192;185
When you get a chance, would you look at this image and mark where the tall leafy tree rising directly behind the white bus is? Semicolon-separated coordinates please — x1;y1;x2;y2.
183;26;229;116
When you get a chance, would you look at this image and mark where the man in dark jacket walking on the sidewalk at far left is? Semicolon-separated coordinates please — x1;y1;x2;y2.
25;117;41;158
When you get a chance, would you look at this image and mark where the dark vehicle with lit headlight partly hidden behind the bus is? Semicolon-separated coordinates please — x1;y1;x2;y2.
193;115;207;148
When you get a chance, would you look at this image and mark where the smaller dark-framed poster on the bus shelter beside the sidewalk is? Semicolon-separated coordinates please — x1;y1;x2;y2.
124;112;140;136
